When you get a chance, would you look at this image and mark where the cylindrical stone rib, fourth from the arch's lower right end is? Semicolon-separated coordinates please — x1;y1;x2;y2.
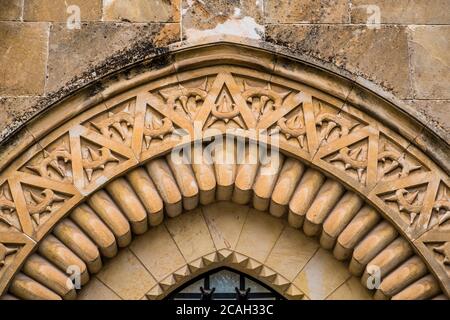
349;221;397;276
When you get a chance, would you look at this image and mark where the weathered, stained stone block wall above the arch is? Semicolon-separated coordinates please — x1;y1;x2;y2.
0;0;450;140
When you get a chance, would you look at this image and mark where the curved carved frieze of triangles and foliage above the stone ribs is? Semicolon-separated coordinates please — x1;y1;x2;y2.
0;61;450;298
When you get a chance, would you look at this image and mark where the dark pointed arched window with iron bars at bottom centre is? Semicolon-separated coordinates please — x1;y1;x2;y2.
167;267;284;301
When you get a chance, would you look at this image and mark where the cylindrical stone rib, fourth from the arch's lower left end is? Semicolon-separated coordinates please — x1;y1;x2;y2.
53;219;102;273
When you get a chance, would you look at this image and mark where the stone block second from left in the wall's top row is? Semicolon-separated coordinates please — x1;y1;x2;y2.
23;0;102;22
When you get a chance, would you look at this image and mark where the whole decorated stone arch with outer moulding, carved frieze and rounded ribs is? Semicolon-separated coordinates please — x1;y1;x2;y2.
0;40;450;298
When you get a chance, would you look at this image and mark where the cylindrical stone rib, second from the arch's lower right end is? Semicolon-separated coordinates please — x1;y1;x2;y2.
374;256;428;300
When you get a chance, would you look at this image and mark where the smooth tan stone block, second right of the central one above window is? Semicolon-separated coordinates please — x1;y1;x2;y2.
266;227;319;281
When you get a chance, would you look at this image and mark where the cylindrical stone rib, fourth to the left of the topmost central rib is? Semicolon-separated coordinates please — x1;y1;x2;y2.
127;168;164;227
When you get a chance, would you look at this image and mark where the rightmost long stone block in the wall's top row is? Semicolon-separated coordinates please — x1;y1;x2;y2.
351;0;450;24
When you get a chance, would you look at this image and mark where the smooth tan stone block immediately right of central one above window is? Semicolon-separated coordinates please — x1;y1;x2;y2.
236;209;286;262
